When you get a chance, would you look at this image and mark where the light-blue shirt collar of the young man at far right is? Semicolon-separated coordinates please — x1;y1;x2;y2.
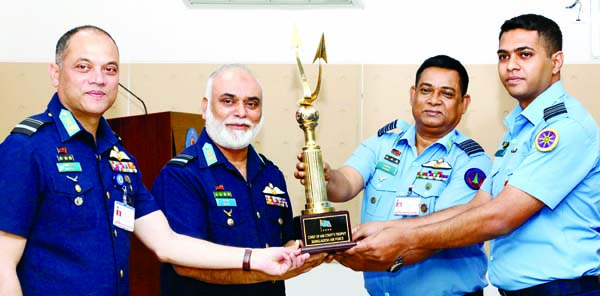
504;80;566;129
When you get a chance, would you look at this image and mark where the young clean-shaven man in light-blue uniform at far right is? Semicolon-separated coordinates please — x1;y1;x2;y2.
344;14;600;296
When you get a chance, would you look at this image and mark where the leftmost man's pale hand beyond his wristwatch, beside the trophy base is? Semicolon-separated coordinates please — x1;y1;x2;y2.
250;243;310;276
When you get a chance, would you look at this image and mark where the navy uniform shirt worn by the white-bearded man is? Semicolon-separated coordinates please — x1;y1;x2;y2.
152;130;293;296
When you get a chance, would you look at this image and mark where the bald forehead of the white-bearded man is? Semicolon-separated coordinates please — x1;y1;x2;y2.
213;68;262;98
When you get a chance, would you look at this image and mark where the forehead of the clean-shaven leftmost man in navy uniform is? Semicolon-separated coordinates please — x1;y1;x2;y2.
63;29;119;63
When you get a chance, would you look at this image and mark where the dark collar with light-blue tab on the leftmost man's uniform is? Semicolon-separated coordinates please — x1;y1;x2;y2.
48;93;117;151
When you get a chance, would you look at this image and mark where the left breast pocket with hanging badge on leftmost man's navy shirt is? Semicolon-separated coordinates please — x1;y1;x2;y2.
50;175;97;231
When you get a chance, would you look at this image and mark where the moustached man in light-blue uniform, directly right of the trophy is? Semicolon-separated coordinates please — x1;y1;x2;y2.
295;55;491;296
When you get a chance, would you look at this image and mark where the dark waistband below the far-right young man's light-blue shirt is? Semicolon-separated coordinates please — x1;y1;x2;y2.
498;276;600;296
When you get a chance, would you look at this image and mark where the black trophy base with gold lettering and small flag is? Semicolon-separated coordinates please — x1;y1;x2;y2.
294;211;356;254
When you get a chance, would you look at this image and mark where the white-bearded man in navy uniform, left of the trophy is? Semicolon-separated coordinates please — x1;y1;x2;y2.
152;64;325;296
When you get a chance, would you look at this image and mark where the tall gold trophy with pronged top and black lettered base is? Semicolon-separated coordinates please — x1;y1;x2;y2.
294;31;356;253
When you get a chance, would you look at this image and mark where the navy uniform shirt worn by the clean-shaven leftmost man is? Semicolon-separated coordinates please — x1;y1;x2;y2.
0;94;158;296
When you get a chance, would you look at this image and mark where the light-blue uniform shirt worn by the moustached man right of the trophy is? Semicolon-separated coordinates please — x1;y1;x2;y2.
345;122;491;296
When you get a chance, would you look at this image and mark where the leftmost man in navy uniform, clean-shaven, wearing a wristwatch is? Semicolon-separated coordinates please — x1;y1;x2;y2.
0;26;305;295
